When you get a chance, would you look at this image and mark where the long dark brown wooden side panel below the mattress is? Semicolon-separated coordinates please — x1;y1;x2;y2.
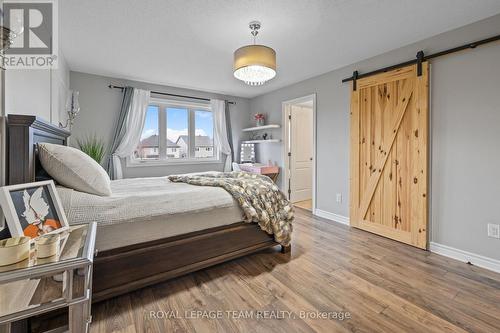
92;222;278;302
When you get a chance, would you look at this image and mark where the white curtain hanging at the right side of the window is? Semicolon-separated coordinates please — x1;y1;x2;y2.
210;99;232;172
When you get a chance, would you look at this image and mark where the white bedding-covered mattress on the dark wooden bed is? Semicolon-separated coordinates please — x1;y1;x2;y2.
58;177;243;251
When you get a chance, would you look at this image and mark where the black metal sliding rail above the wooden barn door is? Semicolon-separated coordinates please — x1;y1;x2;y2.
342;35;500;87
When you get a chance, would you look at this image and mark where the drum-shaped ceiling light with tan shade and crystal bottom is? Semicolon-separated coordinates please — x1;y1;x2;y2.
233;21;276;86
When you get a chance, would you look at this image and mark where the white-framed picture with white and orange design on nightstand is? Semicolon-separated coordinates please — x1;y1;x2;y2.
0;180;68;238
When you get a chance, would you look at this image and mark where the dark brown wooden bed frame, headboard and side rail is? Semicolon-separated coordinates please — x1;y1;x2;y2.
6;115;290;302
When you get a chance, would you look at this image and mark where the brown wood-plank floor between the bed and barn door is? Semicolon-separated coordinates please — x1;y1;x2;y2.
91;209;500;333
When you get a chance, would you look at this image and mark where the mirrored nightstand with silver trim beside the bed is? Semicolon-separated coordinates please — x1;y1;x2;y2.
0;222;96;333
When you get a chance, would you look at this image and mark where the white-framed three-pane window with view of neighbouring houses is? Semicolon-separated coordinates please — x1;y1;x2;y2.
130;100;219;164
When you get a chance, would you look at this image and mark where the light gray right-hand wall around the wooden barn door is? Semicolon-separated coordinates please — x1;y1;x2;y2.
250;15;500;259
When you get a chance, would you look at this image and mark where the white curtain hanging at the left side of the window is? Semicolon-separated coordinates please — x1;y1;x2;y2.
112;88;151;179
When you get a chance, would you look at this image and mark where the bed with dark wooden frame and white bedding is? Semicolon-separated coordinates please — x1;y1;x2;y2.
6;115;290;302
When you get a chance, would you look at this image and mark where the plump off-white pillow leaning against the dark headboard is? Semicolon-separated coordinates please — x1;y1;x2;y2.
38;143;111;196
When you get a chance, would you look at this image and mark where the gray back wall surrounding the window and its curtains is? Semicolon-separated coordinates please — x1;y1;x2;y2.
70;72;250;177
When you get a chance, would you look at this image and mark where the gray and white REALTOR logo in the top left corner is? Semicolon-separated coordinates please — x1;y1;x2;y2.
2;0;58;69
